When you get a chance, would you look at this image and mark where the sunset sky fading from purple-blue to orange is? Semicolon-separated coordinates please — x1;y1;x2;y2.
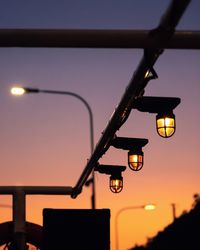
0;0;200;250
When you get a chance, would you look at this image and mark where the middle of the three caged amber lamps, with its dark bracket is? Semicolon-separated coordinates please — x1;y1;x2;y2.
111;137;148;171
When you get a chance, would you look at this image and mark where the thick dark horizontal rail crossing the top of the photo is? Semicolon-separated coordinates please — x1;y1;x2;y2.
0;29;200;49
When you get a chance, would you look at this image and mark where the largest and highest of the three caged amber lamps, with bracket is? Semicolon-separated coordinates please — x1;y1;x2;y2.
133;96;181;138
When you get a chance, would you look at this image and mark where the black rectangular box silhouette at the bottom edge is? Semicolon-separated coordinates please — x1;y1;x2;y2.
42;209;110;250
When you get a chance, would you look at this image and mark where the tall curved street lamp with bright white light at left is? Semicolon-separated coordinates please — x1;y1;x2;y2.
11;87;96;209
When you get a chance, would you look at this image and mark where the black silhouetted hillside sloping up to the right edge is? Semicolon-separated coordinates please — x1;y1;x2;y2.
130;202;200;250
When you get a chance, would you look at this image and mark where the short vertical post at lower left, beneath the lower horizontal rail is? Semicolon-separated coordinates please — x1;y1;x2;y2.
12;188;27;250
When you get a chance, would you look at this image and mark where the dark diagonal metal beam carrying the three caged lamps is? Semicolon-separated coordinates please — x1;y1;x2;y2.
72;0;190;198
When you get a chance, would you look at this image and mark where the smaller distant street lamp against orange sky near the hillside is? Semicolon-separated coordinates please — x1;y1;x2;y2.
115;204;156;250
